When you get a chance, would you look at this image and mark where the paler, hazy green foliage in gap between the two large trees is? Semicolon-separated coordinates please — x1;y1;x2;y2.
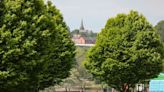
60;47;92;86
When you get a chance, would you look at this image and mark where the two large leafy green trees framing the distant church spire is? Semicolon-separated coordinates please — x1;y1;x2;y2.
0;0;163;92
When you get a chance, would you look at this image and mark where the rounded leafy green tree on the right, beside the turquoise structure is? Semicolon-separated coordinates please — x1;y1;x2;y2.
85;11;163;92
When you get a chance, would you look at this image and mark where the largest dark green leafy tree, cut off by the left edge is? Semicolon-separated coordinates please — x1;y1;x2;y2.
0;0;75;92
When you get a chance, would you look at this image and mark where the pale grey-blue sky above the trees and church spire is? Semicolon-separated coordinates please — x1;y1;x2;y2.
51;0;164;32
